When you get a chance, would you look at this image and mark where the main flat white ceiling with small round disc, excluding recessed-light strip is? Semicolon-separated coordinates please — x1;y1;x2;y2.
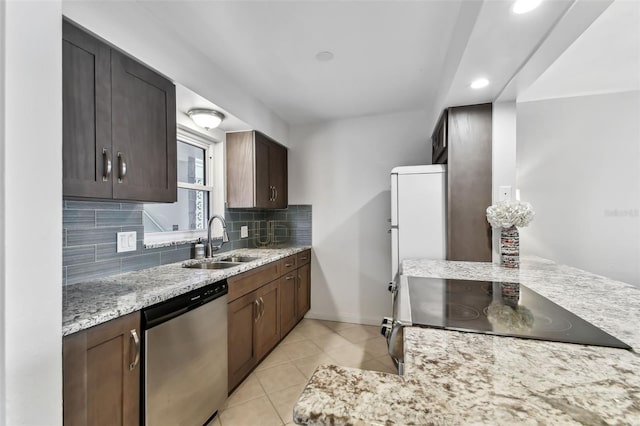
143;1;461;124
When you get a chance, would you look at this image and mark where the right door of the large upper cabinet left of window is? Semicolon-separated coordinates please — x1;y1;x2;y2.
111;50;177;202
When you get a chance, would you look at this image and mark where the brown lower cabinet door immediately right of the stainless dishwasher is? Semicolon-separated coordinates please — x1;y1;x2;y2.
227;291;259;392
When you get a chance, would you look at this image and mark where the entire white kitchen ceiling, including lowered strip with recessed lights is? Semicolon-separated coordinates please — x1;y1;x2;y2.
137;0;609;125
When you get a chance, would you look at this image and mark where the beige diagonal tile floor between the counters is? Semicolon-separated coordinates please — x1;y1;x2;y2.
209;319;396;426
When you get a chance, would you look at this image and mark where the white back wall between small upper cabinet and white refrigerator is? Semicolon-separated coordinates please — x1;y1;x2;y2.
289;111;431;324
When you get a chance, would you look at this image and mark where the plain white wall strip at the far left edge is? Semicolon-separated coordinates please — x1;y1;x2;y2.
0;0;62;426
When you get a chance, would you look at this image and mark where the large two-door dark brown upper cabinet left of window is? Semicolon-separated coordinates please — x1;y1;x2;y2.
62;21;177;202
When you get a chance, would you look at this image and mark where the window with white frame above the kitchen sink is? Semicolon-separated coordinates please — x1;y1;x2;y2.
143;127;215;242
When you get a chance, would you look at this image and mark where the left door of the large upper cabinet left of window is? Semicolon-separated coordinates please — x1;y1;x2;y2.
62;21;112;198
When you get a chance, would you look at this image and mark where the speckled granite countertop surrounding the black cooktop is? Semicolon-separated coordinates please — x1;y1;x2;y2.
294;257;640;425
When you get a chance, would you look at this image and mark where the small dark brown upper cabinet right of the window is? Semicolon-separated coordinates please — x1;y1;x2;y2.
226;131;288;209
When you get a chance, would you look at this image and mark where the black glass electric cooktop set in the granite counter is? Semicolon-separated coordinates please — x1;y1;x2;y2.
409;277;631;349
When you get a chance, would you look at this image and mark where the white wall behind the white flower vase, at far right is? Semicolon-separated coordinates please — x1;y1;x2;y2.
517;91;640;286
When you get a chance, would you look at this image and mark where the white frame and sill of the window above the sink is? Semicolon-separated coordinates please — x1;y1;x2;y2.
143;124;222;245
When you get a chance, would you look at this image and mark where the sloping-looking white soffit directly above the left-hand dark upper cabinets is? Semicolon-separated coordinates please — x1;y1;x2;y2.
63;0;289;145
